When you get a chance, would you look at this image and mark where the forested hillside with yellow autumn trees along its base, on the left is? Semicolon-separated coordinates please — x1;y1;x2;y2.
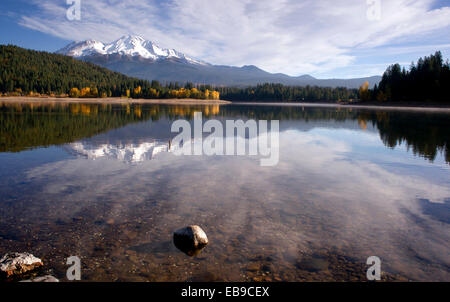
0;45;220;99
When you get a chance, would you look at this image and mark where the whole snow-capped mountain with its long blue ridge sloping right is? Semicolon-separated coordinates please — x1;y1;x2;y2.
57;35;381;88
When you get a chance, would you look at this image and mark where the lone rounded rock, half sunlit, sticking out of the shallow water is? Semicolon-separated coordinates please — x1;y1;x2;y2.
173;225;208;256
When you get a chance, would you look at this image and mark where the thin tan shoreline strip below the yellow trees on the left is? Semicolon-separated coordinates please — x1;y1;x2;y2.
0;96;231;105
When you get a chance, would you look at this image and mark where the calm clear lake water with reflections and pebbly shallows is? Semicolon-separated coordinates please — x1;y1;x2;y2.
0;103;450;281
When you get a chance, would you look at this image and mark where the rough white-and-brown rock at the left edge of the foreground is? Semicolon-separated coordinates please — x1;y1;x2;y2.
0;253;44;278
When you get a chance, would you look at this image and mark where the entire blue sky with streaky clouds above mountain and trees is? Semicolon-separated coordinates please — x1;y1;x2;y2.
0;0;450;78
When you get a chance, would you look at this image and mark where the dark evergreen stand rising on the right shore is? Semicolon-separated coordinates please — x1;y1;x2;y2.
359;51;450;104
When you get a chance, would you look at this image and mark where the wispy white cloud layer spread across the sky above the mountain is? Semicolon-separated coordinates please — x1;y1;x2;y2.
16;0;450;75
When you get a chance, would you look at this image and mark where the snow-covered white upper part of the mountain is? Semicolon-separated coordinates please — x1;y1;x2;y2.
57;35;206;65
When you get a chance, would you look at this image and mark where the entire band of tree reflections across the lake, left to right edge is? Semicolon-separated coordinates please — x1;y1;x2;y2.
0;103;450;163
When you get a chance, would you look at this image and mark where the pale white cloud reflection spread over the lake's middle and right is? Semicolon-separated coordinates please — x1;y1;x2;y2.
28;129;450;280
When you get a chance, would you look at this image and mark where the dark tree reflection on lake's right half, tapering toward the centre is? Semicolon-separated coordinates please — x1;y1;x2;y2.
216;106;450;163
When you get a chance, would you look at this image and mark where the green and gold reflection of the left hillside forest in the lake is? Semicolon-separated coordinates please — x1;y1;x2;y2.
0;103;219;152
